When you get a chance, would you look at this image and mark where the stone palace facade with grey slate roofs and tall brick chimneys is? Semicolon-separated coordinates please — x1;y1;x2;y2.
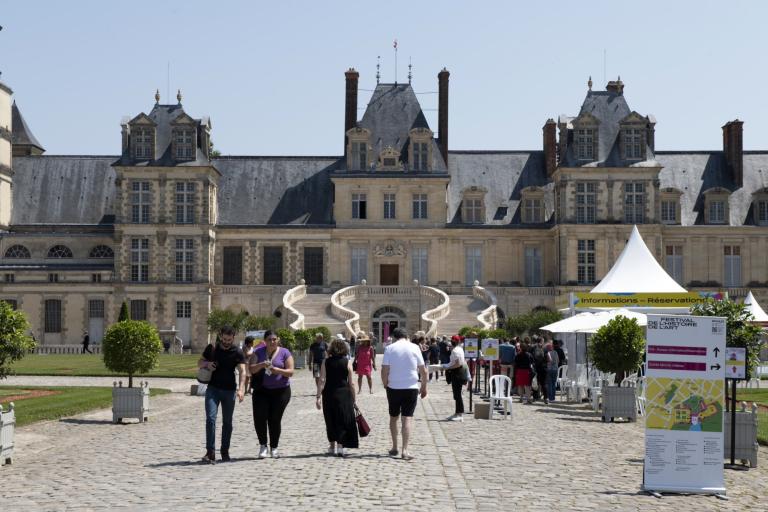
0;69;768;349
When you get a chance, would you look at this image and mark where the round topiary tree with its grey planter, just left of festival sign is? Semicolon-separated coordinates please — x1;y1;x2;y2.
589;316;645;421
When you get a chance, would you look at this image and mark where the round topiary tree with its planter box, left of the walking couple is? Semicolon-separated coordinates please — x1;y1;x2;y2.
102;320;163;423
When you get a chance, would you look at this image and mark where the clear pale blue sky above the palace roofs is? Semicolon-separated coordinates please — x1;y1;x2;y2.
0;0;768;155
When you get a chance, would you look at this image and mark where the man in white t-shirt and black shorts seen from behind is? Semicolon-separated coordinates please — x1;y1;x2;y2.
381;327;427;460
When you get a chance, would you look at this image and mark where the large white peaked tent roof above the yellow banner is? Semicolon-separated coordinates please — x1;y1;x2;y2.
591;226;686;293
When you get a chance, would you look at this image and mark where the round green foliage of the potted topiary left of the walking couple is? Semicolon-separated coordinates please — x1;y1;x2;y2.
101;320;163;387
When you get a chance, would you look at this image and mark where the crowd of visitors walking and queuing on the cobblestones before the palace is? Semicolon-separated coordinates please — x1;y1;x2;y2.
198;327;567;463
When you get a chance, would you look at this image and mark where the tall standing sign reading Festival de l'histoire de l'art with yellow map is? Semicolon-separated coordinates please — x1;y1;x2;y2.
643;315;726;494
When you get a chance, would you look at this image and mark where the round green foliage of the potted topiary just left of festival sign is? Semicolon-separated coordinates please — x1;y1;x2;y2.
589;315;645;382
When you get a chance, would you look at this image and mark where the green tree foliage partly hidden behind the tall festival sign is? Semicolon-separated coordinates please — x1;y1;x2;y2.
691;298;762;379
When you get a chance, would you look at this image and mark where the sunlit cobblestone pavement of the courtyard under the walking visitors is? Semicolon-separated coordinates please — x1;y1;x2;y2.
0;370;768;512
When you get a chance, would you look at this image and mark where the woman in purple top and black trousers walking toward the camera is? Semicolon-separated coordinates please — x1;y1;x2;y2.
249;331;293;459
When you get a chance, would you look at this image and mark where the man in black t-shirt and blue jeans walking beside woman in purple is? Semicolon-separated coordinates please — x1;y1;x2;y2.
197;326;245;464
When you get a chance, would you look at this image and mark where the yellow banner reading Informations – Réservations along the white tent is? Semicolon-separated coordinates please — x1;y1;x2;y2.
573;292;725;309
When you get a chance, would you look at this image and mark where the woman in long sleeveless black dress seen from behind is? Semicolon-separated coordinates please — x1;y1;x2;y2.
316;340;358;457
